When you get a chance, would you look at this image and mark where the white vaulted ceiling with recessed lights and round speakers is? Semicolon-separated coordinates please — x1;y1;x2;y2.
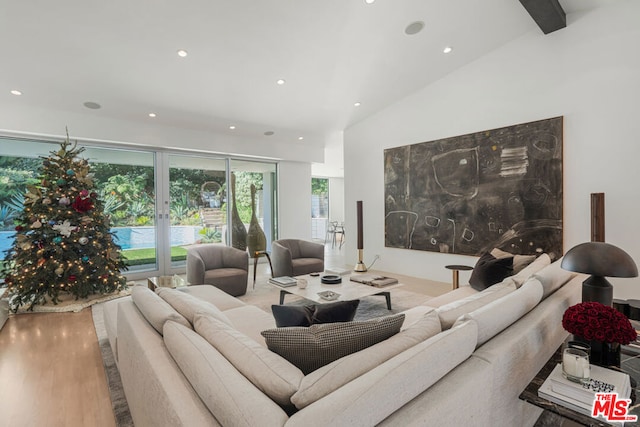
0;0;615;162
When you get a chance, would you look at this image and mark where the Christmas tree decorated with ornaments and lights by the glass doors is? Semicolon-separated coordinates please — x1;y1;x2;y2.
0;135;126;311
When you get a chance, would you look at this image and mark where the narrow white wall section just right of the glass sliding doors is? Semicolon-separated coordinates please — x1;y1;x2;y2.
278;162;311;240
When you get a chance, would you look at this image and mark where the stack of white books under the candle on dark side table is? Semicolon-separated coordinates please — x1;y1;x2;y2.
538;363;631;416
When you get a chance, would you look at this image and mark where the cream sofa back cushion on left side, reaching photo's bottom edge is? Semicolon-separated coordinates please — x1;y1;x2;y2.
164;322;288;427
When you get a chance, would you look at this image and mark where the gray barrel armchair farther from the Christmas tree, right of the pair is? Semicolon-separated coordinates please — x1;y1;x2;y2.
271;239;324;277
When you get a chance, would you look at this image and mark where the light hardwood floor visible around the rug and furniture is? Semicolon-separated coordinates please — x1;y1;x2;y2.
0;245;451;427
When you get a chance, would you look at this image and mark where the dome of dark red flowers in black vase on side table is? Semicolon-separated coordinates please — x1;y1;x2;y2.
562;302;637;344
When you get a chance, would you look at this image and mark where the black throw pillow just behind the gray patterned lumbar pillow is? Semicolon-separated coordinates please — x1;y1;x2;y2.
271;300;360;328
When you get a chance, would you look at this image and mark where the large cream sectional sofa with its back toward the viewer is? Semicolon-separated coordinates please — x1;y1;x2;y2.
104;255;584;427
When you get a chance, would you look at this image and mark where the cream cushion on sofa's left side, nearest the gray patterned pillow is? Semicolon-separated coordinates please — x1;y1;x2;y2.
194;312;304;405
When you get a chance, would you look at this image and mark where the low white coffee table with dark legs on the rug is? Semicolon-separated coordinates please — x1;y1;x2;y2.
269;274;402;310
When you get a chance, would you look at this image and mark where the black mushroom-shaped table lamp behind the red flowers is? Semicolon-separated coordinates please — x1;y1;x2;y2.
560;242;638;307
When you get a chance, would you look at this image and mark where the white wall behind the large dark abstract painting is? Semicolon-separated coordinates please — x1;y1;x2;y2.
345;0;640;298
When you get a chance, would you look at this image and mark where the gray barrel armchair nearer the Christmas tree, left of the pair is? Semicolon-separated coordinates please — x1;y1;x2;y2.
187;244;249;296
